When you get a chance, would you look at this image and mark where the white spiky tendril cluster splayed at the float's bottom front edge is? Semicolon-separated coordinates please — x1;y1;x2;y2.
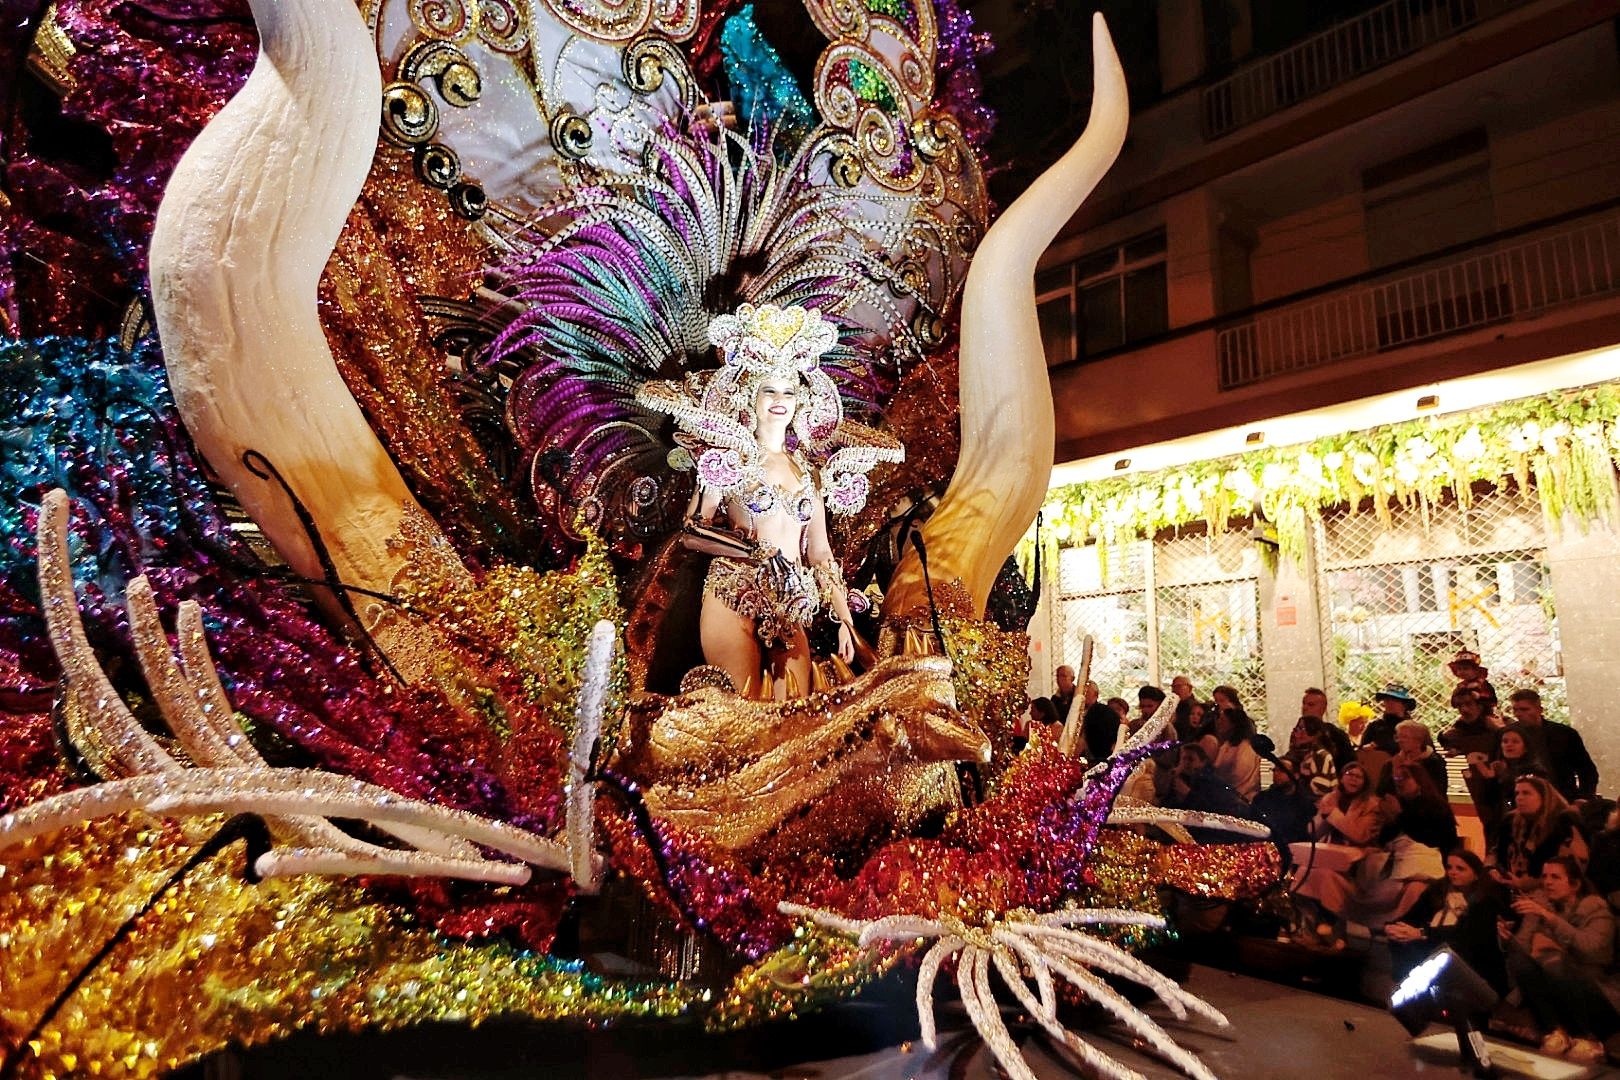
779;904;1230;1080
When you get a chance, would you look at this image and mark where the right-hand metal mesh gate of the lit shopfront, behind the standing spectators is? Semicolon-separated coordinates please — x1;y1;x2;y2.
1317;489;1563;725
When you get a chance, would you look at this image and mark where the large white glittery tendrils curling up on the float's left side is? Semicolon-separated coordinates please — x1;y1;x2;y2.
0;489;614;891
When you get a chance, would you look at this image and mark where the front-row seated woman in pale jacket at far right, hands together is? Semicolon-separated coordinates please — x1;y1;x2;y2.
1497;855;1620;1065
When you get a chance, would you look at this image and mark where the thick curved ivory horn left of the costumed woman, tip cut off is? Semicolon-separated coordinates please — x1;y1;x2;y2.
151;0;462;677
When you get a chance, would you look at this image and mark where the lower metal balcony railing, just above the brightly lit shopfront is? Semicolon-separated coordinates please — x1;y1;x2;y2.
1215;214;1620;390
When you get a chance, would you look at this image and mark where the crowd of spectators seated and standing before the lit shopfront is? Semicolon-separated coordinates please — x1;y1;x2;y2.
1032;653;1620;1062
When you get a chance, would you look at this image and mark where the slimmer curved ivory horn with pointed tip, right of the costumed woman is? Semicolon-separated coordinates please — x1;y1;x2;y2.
883;15;1131;615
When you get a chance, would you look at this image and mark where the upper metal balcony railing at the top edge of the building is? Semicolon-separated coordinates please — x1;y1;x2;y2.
1202;0;1524;139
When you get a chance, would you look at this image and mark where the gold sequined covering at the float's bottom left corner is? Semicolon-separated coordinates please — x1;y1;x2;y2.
0;814;698;1077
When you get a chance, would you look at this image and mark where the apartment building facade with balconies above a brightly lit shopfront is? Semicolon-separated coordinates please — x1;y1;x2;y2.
1034;0;1620;776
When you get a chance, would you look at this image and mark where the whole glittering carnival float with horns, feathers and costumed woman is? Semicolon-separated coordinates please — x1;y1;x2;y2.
0;0;1278;1077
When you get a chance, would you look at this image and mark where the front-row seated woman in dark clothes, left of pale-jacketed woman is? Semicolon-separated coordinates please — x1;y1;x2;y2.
1383;847;1508;997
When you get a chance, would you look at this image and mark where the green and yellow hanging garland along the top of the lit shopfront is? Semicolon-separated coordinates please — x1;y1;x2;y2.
1021;384;1620;560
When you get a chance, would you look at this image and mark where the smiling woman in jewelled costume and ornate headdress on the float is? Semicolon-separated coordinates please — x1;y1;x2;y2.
637;304;904;696
